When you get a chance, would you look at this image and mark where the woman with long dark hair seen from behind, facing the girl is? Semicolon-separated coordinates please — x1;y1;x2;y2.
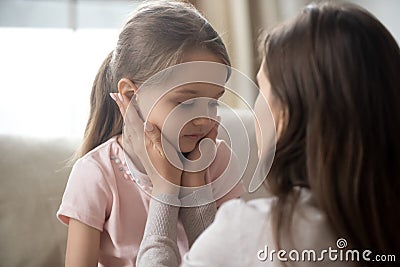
115;3;400;266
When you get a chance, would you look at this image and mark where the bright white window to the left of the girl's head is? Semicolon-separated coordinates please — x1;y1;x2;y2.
0;0;138;138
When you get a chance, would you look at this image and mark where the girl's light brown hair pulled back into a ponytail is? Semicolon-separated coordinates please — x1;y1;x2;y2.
73;1;230;161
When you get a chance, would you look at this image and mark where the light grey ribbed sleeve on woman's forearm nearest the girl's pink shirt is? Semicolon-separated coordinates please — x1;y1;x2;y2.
136;195;181;267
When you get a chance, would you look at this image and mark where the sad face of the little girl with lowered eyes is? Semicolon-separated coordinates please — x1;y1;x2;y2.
148;50;226;153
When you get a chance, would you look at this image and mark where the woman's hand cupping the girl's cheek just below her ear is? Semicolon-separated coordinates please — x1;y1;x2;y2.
112;94;182;195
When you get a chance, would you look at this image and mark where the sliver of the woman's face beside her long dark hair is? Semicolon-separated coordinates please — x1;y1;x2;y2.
254;64;282;156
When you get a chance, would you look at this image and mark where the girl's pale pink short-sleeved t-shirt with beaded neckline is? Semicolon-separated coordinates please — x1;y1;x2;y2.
57;136;244;266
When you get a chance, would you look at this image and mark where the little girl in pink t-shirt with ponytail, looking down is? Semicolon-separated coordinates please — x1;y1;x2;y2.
57;1;243;266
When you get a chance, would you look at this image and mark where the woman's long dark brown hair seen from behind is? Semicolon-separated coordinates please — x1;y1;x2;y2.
263;3;400;262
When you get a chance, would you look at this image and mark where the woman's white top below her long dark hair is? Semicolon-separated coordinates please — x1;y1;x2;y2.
137;188;350;267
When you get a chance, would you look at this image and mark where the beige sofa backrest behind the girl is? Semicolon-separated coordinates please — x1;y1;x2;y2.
0;110;266;267
